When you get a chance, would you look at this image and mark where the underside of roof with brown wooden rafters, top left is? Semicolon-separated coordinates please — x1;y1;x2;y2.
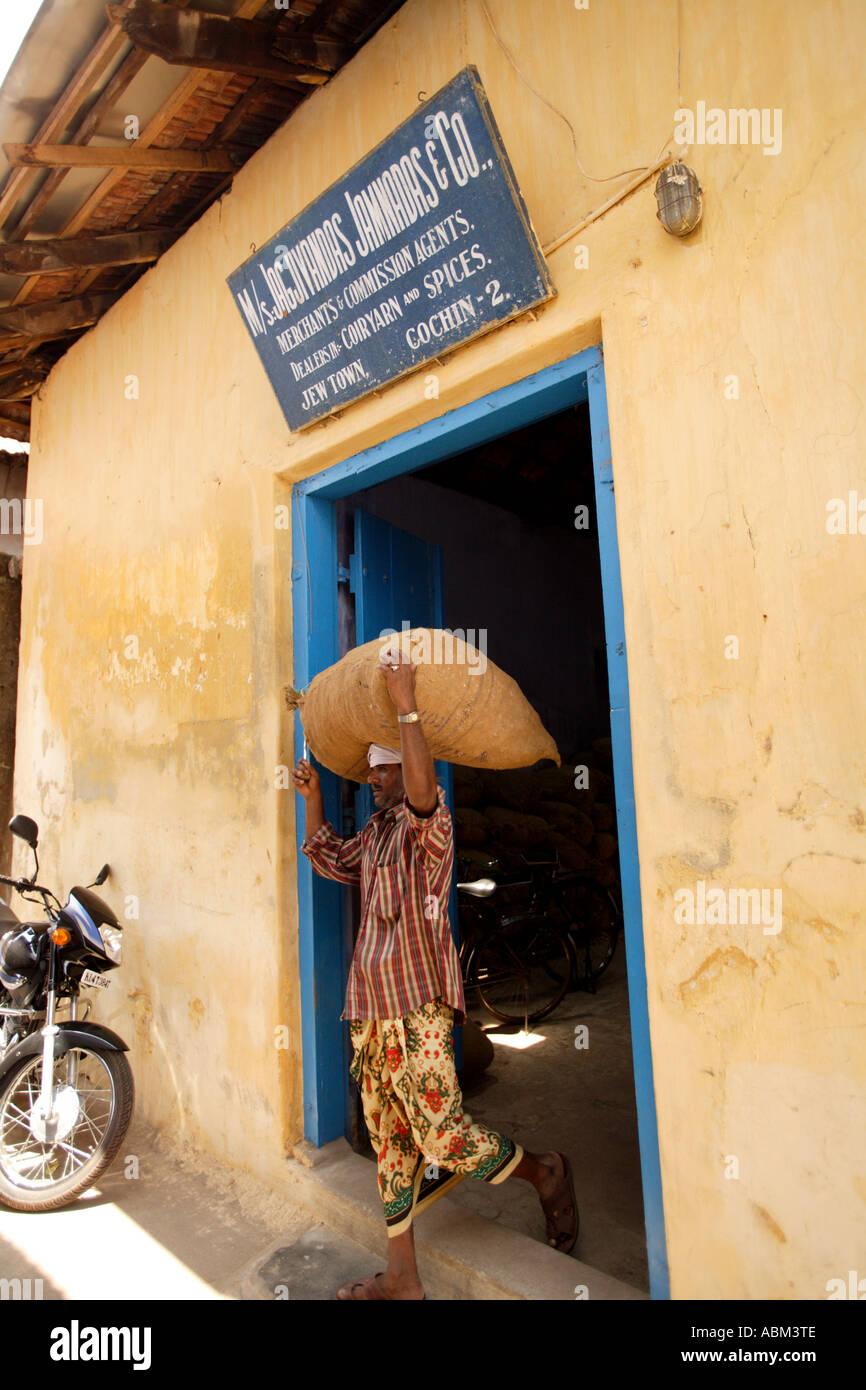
0;0;402;438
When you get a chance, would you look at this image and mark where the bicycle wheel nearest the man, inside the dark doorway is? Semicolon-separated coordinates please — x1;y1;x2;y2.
475;922;571;1026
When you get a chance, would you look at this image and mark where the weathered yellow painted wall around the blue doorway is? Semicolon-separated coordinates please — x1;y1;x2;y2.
17;0;866;1298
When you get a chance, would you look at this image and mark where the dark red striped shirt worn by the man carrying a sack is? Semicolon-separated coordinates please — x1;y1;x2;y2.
300;787;466;1023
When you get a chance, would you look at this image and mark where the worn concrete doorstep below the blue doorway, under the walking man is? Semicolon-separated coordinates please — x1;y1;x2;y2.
240;1138;646;1301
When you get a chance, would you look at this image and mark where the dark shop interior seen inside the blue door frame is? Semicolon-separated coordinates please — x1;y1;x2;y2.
336;402;649;1290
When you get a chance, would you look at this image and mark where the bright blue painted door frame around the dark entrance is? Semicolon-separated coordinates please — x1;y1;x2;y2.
292;348;669;1298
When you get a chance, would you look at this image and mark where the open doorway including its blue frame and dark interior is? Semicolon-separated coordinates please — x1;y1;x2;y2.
293;348;669;1298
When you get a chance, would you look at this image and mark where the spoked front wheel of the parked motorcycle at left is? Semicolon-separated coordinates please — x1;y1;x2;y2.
0;1047;135;1212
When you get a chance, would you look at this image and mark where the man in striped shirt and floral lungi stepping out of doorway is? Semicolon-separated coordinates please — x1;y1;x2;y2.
293;649;578;1300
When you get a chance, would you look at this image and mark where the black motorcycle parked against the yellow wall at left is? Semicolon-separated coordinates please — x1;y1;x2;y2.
0;816;135;1212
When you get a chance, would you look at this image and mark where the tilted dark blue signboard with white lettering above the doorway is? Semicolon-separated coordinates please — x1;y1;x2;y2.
228;67;556;430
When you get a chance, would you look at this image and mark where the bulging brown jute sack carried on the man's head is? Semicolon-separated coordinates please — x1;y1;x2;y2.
289;627;560;781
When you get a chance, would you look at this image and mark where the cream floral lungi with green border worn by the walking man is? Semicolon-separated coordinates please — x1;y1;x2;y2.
349;999;523;1236
